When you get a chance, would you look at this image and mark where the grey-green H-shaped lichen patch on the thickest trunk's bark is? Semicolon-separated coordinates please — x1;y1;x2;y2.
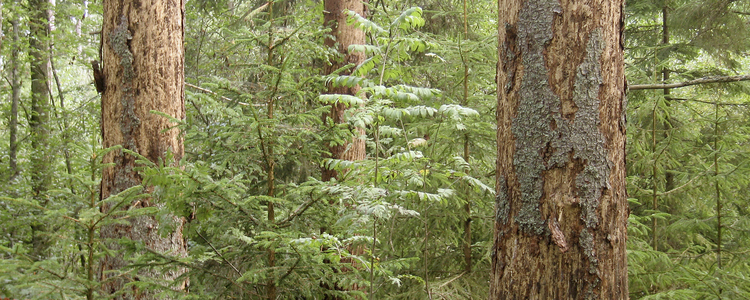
512;0;611;234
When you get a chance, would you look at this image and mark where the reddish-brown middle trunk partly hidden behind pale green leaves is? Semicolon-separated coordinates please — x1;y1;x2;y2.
323;0;366;181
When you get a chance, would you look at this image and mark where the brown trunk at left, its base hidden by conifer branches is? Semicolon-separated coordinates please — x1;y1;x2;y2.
101;0;186;299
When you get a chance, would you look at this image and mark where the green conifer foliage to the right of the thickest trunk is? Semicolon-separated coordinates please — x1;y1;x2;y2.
625;0;750;299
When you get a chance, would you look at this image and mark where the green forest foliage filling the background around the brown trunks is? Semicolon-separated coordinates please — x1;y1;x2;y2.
0;0;750;299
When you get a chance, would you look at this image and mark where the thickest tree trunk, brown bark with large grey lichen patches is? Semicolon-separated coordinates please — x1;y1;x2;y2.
490;0;628;299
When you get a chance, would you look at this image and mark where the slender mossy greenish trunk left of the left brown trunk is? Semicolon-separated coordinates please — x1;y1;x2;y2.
29;0;52;259
